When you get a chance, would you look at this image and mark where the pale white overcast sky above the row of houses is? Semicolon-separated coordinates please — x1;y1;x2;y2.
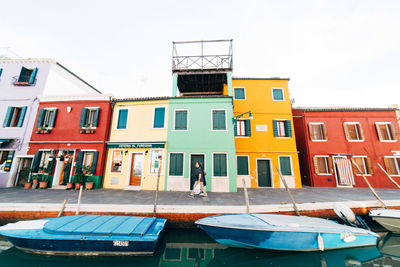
0;0;400;107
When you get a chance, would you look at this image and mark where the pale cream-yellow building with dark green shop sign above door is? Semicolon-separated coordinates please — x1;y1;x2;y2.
103;97;169;190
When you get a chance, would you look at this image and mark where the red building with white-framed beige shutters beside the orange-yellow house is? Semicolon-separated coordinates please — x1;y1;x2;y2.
293;108;400;188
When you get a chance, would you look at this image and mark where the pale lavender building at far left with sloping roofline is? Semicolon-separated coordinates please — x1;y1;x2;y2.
0;59;100;187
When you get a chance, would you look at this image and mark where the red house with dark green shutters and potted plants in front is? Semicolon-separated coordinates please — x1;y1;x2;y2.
28;95;111;188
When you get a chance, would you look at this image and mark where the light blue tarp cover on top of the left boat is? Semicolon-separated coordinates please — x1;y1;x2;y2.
43;215;156;236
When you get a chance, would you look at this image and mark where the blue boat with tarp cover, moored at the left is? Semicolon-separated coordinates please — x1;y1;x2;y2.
0;215;167;256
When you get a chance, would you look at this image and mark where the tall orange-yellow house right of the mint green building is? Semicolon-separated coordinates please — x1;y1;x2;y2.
232;78;301;188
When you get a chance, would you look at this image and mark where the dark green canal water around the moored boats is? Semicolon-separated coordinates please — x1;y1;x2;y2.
0;229;400;267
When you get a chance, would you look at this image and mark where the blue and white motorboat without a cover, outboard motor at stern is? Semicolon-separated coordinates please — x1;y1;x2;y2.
196;213;379;251
